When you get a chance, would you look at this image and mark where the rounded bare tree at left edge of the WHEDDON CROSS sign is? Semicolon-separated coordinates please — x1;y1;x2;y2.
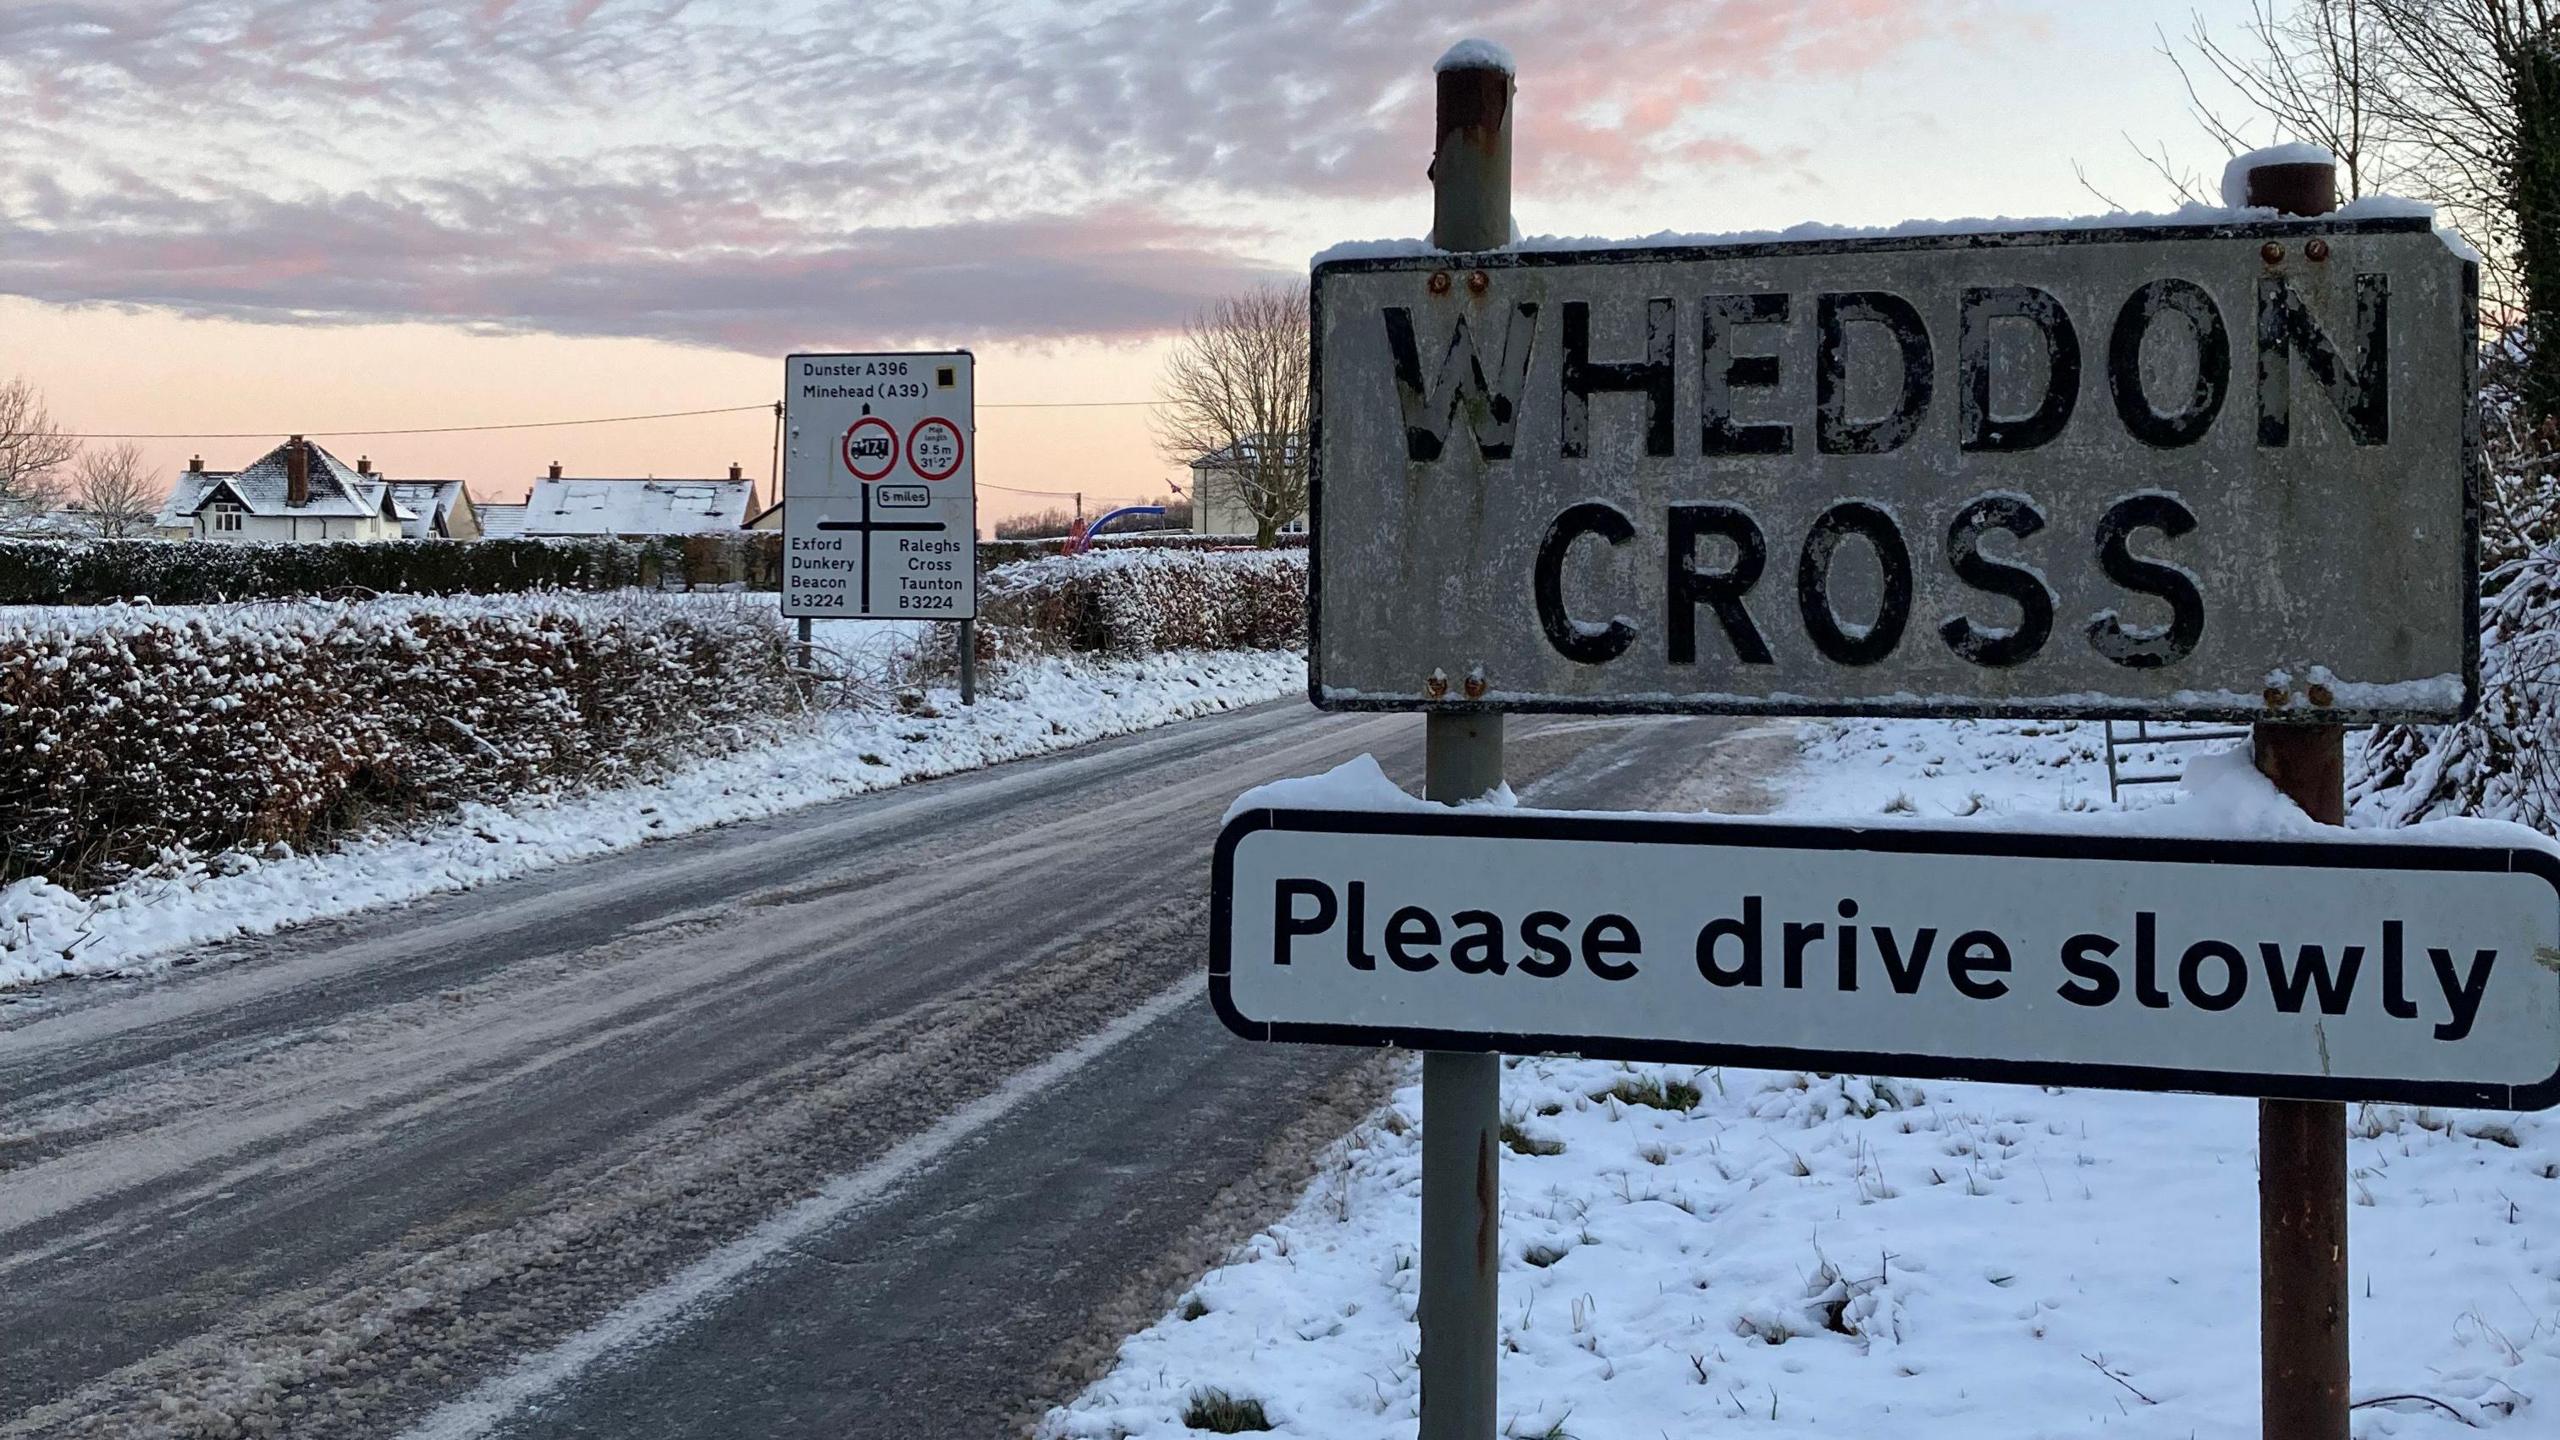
1155;282;1308;548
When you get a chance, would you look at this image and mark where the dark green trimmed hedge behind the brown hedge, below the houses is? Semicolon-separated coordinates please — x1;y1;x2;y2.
0;533;781;605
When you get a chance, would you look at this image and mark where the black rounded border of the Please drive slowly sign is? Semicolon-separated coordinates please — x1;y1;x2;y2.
1208;807;2560;1109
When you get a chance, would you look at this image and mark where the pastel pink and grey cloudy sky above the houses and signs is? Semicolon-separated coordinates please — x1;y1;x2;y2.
0;0;2283;527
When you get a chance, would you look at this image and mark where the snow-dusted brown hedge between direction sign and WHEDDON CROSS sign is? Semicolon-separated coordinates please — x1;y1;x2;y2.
980;548;1306;656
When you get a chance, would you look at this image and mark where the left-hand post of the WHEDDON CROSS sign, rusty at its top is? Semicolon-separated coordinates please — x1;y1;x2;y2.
1416;41;1510;1440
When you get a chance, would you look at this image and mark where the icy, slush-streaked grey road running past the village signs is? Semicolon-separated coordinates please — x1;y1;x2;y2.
0;702;1792;1440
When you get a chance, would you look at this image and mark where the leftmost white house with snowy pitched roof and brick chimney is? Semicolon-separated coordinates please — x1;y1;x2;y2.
156;436;417;543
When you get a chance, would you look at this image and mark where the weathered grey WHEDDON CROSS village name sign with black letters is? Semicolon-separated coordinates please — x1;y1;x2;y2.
1308;218;2478;723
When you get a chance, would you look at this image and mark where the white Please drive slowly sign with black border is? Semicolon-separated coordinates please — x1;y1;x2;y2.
1208;810;2560;1109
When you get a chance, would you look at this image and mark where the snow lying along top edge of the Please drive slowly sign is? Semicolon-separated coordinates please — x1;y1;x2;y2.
1226;746;2560;856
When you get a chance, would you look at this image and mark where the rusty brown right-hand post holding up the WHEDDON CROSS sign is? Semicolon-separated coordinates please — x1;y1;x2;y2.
2248;164;2348;1440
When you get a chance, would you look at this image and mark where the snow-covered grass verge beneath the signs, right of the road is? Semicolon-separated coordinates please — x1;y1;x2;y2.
1042;720;2560;1440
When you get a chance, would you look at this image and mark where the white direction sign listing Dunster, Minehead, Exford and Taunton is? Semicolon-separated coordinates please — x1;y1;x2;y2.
783;351;978;620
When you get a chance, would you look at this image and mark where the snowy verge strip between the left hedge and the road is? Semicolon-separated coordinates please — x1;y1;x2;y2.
0;648;1306;986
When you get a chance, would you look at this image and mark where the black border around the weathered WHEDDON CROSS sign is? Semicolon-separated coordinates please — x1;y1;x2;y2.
1306;215;2481;725
